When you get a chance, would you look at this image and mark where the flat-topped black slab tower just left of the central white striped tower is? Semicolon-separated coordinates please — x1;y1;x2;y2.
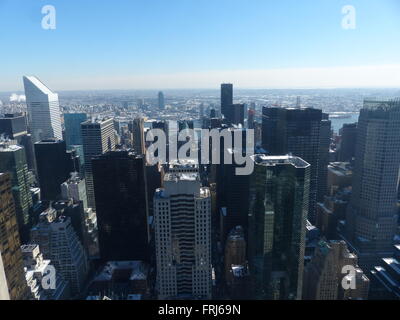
92;151;149;261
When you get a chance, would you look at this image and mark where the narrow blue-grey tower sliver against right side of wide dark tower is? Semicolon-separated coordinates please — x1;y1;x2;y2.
317;113;331;202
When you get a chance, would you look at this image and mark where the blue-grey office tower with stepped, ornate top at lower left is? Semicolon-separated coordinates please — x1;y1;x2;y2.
31;207;88;295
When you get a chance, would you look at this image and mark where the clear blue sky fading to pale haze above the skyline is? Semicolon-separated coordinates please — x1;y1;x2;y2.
0;0;400;92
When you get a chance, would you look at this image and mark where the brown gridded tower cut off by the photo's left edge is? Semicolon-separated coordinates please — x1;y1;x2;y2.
0;173;29;300
